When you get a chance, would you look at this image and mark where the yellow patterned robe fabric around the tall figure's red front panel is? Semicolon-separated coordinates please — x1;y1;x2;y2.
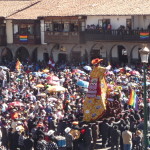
83;66;107;122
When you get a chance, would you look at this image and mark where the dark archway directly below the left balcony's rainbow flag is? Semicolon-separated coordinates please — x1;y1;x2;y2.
16;47;30;62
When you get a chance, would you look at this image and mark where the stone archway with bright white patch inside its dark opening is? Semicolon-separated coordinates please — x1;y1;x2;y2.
110;44;128;65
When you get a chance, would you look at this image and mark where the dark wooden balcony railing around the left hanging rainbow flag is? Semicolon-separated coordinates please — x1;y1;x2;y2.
13;34;41;44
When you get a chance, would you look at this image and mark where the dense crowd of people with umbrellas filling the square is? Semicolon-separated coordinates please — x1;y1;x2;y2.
0;60;150;150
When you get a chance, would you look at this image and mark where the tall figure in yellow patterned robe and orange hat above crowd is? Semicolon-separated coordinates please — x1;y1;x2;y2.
83;58;111;122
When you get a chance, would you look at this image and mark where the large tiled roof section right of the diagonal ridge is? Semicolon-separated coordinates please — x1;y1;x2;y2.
5;0;150;19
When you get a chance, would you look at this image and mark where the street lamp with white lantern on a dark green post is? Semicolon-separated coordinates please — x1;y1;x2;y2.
139;47;150;150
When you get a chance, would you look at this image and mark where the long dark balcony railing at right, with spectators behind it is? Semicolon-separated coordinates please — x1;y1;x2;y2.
82;29;150;42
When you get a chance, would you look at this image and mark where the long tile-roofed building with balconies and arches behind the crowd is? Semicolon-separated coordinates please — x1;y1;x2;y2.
0;0;150;64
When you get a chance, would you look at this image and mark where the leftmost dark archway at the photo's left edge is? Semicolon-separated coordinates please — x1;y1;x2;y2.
1;47;13;63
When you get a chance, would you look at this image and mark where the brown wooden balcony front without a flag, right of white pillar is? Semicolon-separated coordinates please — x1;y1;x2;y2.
45;31;82;44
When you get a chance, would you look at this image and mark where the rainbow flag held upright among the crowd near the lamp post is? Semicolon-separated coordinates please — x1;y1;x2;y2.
128;89;139;110
